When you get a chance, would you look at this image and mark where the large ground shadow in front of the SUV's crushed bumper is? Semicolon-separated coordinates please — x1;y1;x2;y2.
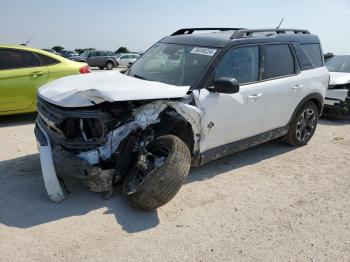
0;154;159;233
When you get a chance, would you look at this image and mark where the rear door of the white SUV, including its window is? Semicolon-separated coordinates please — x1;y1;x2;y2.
262;43;308;131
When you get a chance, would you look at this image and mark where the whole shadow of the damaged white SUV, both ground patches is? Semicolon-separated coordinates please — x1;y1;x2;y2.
0;138;293;233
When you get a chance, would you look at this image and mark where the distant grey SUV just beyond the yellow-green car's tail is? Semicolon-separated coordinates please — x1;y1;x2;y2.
74;50;119;70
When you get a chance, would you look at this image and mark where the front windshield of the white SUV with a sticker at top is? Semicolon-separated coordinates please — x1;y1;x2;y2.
129;43;217;86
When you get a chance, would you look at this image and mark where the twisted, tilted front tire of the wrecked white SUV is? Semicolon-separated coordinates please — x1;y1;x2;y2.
123;135;191;211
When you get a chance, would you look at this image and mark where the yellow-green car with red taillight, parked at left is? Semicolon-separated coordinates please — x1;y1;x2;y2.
0;45;90;115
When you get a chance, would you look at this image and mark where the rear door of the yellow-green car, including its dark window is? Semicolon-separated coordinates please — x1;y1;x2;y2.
0;48;48;112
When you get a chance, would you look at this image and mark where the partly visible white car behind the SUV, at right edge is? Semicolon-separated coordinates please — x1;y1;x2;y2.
324;54;350;119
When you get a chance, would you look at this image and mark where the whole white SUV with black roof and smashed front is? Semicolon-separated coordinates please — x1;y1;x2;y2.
35;28;329;210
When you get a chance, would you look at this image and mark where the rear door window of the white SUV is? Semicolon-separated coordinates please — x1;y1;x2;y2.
264;44;295;79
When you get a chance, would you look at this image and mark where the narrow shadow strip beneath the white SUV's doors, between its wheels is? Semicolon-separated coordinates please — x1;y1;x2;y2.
187;139;295;183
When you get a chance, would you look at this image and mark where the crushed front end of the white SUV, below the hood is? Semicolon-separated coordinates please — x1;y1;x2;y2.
35;97;201;202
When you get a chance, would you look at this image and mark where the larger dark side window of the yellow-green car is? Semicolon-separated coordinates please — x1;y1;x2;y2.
0;49;40;69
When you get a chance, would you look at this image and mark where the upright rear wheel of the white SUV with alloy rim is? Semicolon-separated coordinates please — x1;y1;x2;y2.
283;101;319;146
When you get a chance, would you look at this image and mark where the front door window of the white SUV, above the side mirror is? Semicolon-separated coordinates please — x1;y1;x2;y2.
215;46;259;84
